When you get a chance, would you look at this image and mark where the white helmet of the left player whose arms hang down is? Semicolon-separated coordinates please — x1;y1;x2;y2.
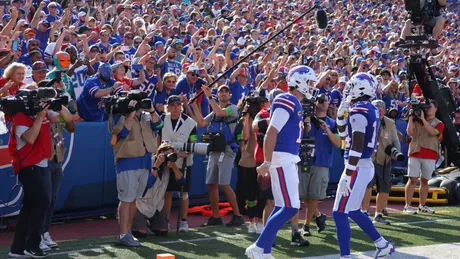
287;65;318;99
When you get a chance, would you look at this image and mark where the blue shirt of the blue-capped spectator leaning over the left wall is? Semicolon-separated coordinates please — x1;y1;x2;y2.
77;75;115;121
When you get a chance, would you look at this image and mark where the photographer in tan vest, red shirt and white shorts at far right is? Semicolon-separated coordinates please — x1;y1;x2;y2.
403;99;444;214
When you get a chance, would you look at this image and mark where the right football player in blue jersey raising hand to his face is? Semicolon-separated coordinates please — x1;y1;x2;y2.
332;73;395;258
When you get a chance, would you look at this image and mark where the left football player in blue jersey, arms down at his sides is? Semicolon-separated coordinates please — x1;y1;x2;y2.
246;66;317;259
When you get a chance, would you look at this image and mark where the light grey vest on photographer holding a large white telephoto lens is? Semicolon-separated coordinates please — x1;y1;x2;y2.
161;113;197;168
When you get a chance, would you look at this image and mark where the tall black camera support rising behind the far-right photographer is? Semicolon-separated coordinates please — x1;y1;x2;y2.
399;25;459;165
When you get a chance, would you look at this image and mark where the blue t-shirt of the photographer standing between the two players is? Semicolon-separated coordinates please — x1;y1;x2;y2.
308;117;337;167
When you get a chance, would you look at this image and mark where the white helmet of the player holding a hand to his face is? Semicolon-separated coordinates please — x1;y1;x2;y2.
344;73;378;101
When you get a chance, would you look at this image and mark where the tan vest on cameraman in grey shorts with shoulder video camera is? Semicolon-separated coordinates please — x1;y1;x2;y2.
108;112;157;163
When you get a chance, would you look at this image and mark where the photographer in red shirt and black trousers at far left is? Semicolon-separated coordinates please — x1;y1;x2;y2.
8;97;72;258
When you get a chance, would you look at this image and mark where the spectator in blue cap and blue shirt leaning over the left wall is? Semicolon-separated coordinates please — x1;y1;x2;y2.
77;63;127;121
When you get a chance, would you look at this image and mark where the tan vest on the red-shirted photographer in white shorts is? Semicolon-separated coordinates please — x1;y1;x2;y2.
409;118;442;155
